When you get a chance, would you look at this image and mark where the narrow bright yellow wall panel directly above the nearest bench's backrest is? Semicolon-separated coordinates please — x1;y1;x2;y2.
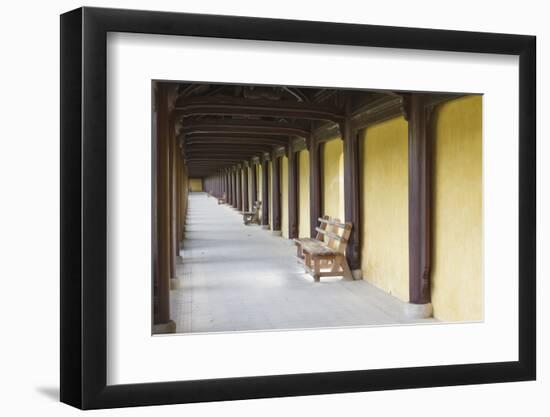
322;138;344;220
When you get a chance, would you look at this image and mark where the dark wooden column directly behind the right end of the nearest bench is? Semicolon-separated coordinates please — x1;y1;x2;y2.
340;100;362;279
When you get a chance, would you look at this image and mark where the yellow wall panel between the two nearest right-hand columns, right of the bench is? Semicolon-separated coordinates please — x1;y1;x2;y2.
360;117;409;301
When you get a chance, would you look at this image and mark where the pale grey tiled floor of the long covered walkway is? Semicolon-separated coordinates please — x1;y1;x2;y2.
170;193;433;333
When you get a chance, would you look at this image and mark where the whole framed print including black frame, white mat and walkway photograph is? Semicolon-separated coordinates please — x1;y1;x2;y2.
60;8;536;409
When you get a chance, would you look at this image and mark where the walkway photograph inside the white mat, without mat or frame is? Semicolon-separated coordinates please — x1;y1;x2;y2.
151;80;484;334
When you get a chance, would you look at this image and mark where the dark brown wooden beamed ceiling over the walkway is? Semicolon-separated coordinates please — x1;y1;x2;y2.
157;83;408;177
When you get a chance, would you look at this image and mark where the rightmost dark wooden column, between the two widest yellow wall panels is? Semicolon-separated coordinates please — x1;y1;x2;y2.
405;94;432;304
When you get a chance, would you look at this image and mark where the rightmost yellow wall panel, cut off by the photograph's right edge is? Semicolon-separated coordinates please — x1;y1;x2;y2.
432;96;483;321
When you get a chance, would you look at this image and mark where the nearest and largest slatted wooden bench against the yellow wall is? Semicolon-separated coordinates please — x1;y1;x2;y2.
301;218;353;282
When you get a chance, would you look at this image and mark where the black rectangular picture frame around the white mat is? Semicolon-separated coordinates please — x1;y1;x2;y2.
60;7;536;409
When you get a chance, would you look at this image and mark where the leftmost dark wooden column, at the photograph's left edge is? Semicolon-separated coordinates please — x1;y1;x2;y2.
153;84;175;332
